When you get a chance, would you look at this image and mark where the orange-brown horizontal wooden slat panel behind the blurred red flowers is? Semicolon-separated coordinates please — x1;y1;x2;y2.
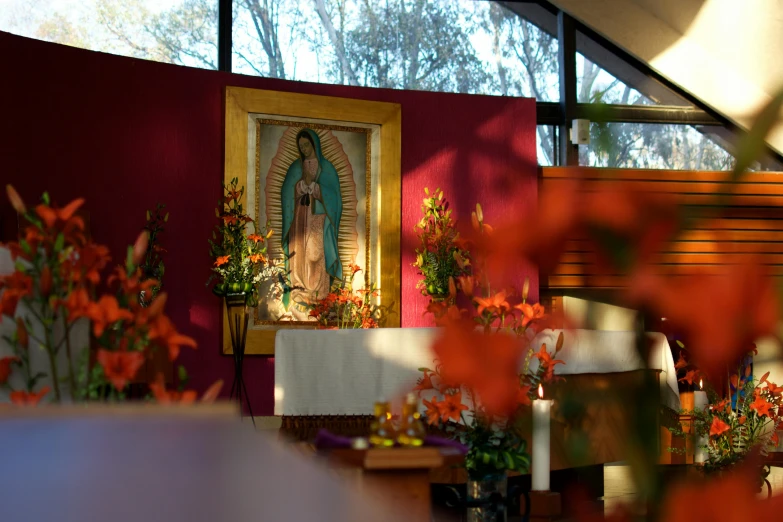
541;167;783;290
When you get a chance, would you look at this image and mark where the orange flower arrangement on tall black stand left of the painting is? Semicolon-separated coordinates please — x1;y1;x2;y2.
207;178;282;306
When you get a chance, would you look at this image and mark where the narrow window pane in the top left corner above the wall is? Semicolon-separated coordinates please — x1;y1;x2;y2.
0;0;218;69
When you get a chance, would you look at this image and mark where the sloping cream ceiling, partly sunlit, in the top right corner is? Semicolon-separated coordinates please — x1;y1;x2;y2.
550;0;783;153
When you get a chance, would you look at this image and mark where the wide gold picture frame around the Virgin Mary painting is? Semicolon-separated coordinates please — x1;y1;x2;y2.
221;87;402;355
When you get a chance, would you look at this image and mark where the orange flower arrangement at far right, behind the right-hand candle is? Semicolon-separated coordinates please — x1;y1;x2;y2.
670;341;783;478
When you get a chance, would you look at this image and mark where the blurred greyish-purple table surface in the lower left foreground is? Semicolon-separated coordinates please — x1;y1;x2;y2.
0;407;410;522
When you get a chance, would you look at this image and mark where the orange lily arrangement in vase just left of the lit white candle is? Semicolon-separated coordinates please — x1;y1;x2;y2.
415;201;564;478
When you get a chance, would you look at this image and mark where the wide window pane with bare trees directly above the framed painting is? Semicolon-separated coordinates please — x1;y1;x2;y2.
233;0;558;101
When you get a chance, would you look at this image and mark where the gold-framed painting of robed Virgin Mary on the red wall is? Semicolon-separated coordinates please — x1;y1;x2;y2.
223;87;401;354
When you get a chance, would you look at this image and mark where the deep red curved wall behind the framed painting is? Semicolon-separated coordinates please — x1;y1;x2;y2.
0;32;538;415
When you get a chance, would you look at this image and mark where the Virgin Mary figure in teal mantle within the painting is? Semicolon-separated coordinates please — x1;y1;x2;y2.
281;129;343;321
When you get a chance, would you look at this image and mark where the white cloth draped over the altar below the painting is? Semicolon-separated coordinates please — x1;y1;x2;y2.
275;328;680;415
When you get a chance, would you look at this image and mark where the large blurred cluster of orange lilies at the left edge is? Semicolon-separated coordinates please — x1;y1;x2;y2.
0;185;222;405
